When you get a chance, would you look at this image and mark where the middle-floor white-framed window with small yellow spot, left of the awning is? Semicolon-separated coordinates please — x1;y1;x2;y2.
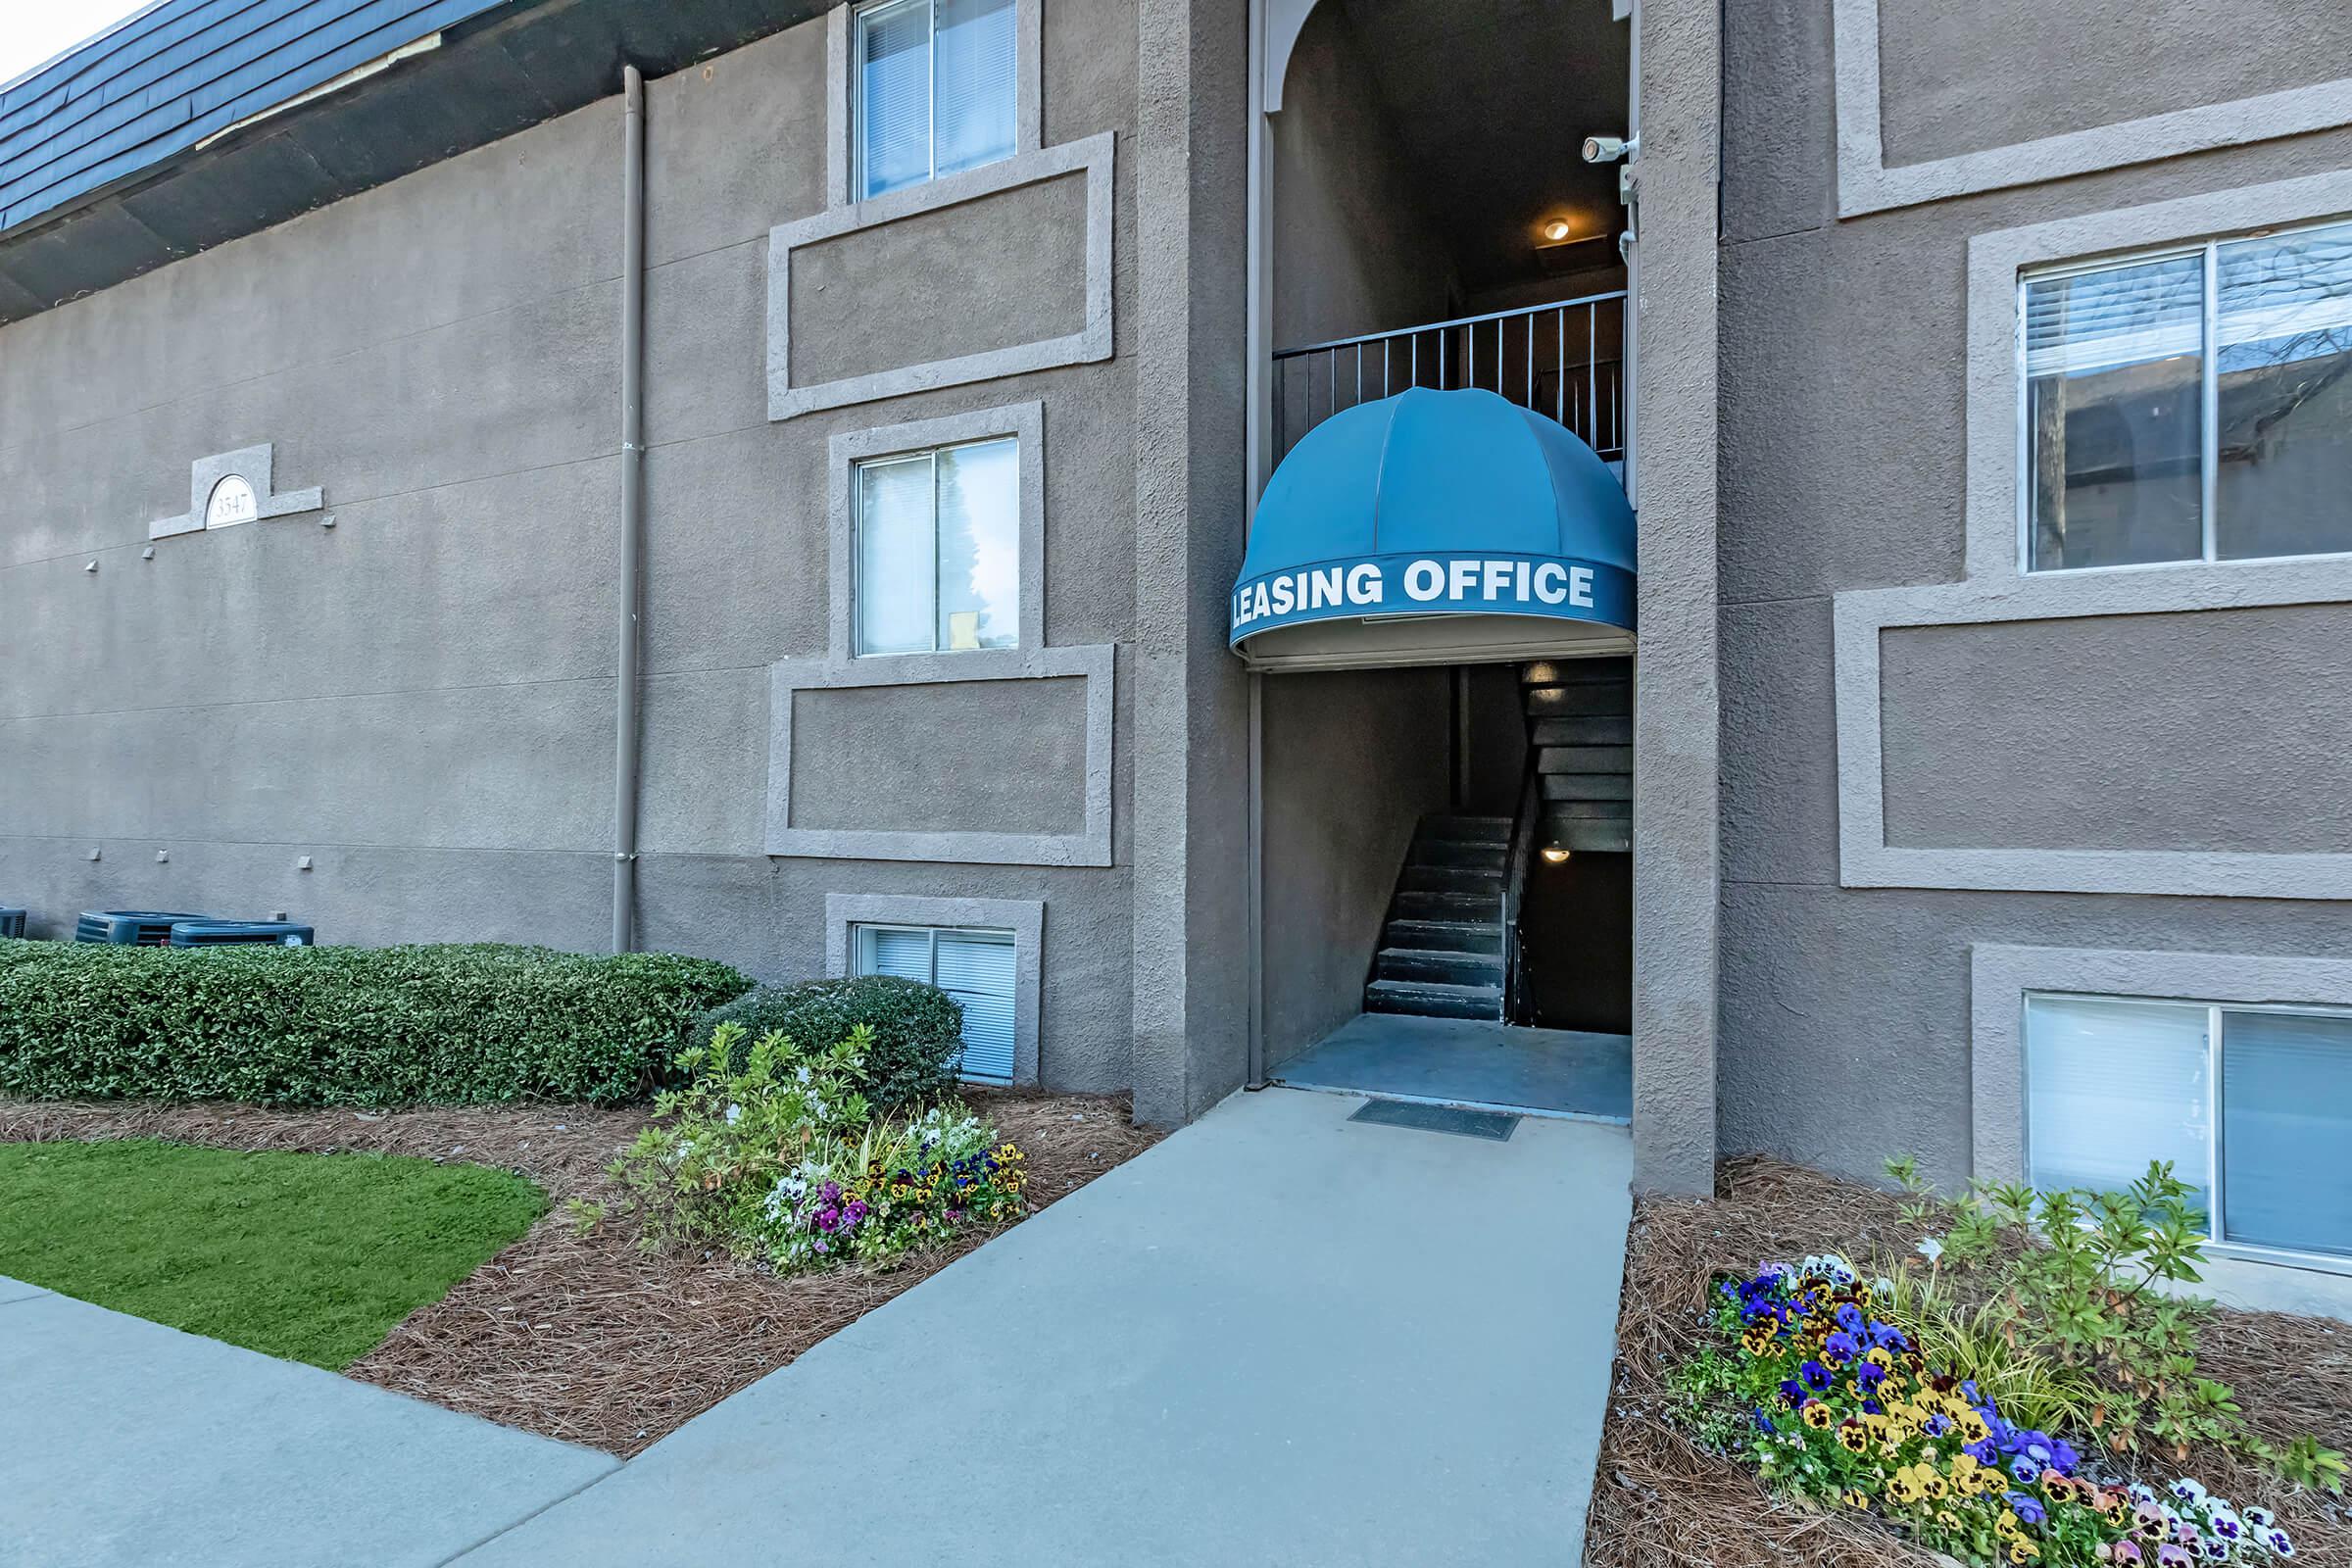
852;437;1021;654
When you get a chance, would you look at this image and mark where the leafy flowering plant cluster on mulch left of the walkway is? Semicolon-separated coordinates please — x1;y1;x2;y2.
610;1020;1025;1272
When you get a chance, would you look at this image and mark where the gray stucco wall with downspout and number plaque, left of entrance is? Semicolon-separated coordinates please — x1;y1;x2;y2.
0;0;1176;1119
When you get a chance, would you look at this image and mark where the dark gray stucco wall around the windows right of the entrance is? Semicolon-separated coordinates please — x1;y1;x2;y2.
1721;0;2352;1180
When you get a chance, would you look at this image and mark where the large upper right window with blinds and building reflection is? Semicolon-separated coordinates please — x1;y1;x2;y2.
2018;213;2352;571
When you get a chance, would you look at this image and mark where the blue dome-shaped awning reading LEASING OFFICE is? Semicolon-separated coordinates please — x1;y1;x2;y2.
1230;388;1635;667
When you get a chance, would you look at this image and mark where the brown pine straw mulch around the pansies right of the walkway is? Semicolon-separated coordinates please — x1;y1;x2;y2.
1586;1159;2352;1568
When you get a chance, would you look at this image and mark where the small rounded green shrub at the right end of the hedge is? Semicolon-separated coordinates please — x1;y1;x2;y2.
694;976;964;1109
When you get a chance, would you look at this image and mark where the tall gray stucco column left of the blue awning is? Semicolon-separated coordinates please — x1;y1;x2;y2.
1122;0;1249;1124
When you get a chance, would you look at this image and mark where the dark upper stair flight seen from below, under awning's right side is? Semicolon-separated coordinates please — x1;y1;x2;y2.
1519;659;1633;854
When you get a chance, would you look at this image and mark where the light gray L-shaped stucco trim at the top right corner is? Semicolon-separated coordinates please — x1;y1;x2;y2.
1835;0;2352;219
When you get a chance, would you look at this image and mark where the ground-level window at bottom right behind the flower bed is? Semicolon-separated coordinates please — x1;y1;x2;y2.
2025;995;2352;1260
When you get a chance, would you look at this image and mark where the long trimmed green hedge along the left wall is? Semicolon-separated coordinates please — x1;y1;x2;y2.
0;941;751;1104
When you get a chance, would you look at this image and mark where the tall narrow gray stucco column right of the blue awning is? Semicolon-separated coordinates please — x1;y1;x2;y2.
1633;0;1722;1192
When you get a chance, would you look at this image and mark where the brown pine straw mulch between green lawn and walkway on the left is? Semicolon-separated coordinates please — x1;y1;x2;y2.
0;1091;1159;1457
